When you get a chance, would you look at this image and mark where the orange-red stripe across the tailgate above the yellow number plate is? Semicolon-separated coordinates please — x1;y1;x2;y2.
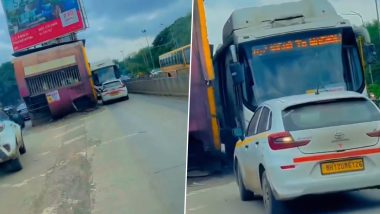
293;148;380;163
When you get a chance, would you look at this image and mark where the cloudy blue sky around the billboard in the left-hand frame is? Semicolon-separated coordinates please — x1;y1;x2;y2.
0;0;192;63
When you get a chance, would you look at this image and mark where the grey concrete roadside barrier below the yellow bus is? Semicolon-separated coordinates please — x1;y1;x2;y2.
127;71;189;96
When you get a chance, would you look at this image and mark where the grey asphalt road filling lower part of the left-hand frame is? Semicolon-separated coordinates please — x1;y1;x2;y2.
0;95;188;214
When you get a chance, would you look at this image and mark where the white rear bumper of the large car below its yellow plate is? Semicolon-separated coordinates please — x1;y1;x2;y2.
267;155;380;200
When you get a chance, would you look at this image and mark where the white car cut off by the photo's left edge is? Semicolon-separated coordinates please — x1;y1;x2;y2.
0;111;26;172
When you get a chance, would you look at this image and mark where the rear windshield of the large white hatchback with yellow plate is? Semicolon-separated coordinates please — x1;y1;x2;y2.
282;99;380;131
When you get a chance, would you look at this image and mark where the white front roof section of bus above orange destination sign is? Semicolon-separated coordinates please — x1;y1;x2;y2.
223;0;351;44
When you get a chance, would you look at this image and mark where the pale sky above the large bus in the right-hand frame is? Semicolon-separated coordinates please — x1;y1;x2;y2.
205;0;380;47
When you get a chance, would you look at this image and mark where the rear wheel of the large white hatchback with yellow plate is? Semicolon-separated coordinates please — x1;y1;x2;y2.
262;172;287;214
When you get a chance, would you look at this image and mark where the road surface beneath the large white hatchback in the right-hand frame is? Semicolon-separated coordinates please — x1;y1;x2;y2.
186;170;380;214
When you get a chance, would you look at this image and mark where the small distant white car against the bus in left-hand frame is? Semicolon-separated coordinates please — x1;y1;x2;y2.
101;79;129;104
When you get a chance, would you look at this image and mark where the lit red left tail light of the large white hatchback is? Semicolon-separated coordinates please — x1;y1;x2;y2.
268;132;310;150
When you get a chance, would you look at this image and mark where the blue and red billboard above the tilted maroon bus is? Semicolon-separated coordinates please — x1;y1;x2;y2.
2;0;85;52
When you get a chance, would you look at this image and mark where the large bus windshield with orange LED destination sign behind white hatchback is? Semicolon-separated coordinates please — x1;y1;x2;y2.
245;30;364;105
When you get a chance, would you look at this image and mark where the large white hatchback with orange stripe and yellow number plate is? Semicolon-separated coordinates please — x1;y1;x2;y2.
234;91;380;213
